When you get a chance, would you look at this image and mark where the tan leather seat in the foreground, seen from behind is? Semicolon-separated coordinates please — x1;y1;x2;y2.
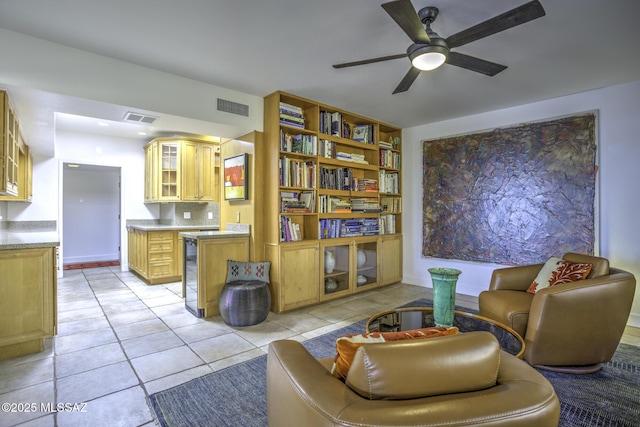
267;332;560;427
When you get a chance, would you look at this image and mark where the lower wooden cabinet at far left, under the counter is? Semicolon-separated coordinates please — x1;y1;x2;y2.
0;247;57;360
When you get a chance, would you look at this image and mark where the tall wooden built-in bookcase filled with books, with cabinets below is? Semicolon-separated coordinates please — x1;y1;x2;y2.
256;92;402;313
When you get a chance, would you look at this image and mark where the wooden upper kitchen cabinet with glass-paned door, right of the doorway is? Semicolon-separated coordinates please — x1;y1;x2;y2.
144;138;220;202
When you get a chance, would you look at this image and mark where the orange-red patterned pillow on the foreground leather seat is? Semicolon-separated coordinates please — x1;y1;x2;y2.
331;326;458;379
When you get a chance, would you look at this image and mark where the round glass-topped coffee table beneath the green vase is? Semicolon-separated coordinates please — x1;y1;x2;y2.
367;307;524;358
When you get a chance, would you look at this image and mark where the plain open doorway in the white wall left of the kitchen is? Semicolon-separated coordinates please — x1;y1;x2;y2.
62;163;121;269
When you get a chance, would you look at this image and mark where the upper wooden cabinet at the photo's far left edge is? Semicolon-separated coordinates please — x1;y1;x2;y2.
0;90;32;201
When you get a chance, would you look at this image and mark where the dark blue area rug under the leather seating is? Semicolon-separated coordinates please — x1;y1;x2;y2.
149;300;640;427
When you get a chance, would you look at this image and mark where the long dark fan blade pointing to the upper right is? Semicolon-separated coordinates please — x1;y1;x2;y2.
445;0;546;49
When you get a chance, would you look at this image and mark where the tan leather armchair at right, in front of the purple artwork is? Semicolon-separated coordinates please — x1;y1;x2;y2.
478;253;636;373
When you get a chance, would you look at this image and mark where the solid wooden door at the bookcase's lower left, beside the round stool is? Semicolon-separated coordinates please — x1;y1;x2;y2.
279;242;320;310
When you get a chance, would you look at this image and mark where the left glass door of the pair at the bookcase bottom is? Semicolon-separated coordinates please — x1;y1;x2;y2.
321;243;351;299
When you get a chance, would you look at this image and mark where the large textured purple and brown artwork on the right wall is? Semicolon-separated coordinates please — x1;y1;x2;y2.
422;114;597;265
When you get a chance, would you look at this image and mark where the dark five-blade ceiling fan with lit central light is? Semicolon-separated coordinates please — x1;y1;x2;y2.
333;0;545;93
